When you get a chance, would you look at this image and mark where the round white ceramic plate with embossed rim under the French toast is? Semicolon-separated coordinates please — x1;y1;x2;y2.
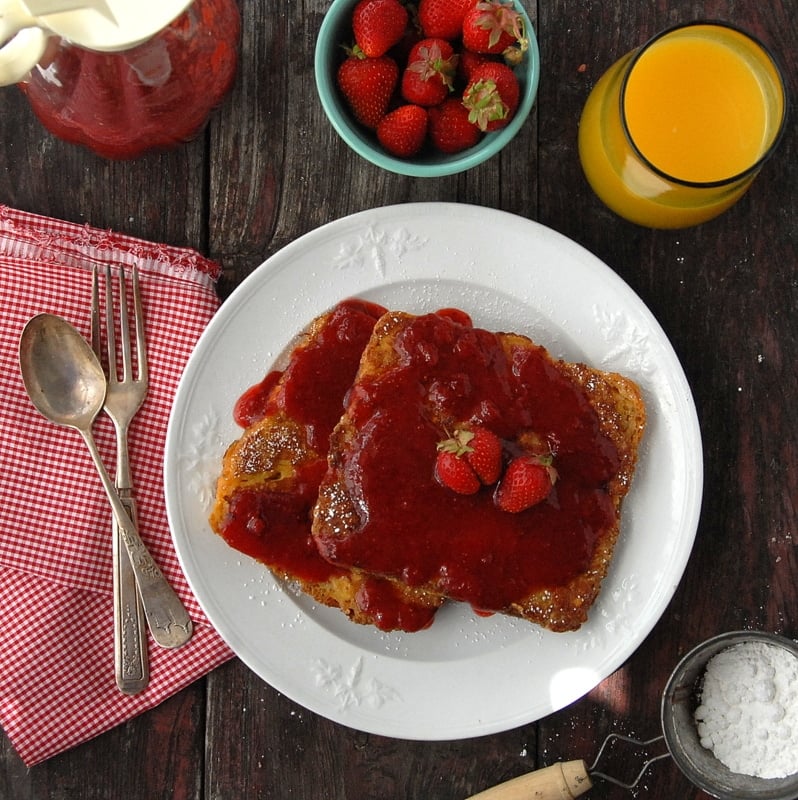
165;203;703;740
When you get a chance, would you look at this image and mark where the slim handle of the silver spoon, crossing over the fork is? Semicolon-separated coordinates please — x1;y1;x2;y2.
80;430;194;648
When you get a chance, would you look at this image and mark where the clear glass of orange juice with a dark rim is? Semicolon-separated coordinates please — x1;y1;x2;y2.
579;21;787;228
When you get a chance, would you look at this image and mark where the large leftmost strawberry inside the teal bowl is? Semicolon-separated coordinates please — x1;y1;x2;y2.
337;47;399;129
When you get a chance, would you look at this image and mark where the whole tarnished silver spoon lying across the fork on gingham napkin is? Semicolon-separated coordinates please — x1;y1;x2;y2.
19;314;193;648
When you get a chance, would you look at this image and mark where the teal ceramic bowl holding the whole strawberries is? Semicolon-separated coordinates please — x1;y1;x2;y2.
314;0;540;178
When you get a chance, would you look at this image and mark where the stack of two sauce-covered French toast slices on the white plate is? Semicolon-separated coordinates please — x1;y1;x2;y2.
211;304;645;631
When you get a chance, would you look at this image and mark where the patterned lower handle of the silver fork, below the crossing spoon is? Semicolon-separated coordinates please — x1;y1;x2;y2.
112;490;150;694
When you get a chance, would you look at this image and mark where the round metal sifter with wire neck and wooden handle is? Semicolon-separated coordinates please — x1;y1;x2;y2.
468;631;798;800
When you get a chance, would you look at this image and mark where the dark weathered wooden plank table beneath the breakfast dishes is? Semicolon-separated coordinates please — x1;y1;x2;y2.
0;0;798;800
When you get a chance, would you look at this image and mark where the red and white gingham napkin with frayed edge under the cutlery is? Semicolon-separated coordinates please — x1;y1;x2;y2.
0;206;231;766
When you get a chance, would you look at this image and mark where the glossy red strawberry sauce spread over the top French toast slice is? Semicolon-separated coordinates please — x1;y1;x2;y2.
318;314;619;610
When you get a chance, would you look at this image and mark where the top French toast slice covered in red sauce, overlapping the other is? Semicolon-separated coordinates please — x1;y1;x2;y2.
313;312;646;631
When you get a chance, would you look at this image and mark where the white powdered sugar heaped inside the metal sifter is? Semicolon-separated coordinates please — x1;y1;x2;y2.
695;642;798;778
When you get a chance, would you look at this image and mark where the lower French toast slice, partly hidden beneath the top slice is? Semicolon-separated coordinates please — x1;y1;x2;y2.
210;301;442;631
